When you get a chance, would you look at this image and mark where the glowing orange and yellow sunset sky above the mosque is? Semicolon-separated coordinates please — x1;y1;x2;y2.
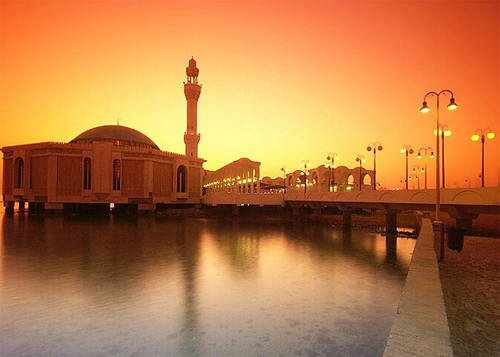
0;0;500;189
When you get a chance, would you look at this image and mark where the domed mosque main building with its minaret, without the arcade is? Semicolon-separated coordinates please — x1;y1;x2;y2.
2;58;205;212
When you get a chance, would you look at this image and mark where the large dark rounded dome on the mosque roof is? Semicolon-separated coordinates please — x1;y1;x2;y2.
70;125;159;149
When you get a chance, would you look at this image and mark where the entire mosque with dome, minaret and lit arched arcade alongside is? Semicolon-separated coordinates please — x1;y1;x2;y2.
1;58;373;213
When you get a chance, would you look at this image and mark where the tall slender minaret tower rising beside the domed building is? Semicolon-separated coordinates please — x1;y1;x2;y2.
184;57;201;158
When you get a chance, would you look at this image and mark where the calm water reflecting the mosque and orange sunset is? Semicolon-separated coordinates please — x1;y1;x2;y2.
0;214;415;356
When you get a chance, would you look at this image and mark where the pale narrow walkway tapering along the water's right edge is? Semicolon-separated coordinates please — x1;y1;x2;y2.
384;218;453;357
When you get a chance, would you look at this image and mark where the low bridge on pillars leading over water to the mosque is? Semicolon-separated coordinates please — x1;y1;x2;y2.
202;187;500;234
